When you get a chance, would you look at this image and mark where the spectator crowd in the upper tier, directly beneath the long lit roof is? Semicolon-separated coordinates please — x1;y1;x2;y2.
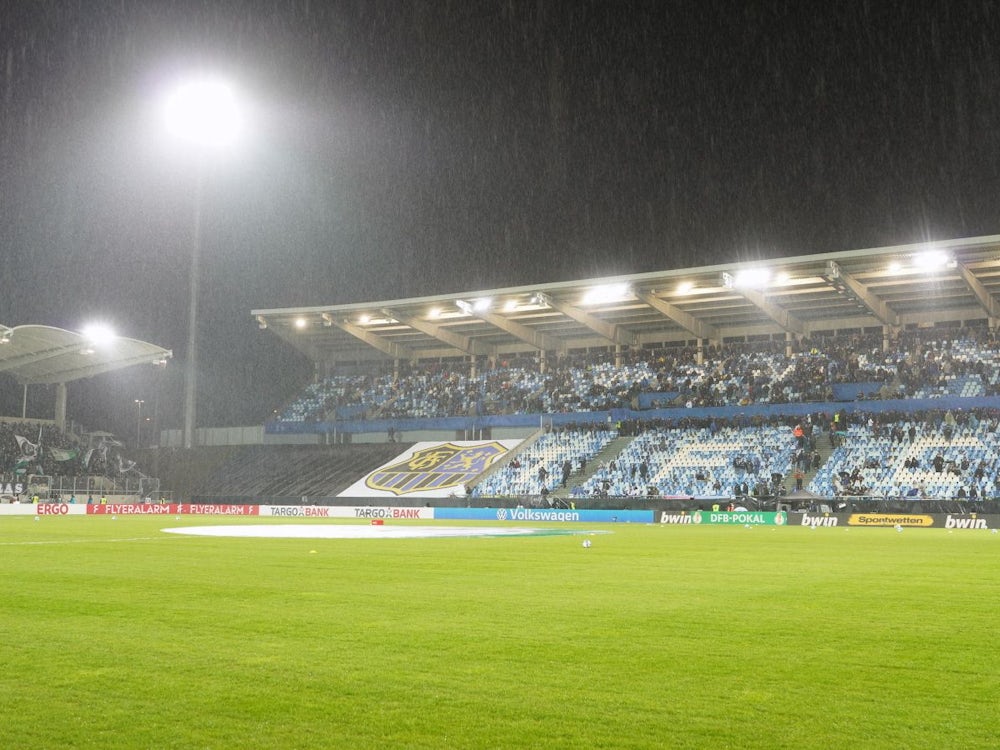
275;329;1000;423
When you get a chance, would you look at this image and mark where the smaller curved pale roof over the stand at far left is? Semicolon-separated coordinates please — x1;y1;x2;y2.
0;325;172;385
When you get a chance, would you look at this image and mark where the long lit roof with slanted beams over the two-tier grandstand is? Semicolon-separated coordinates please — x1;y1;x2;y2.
252;235;1000;365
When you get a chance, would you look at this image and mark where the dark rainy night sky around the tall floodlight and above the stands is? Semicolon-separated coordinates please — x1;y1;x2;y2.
0;0;1000;434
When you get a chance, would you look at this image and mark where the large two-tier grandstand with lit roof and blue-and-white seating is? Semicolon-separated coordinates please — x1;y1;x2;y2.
9;241;1000;507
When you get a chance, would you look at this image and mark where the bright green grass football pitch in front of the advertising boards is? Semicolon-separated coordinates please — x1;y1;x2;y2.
0;516;1000;749
